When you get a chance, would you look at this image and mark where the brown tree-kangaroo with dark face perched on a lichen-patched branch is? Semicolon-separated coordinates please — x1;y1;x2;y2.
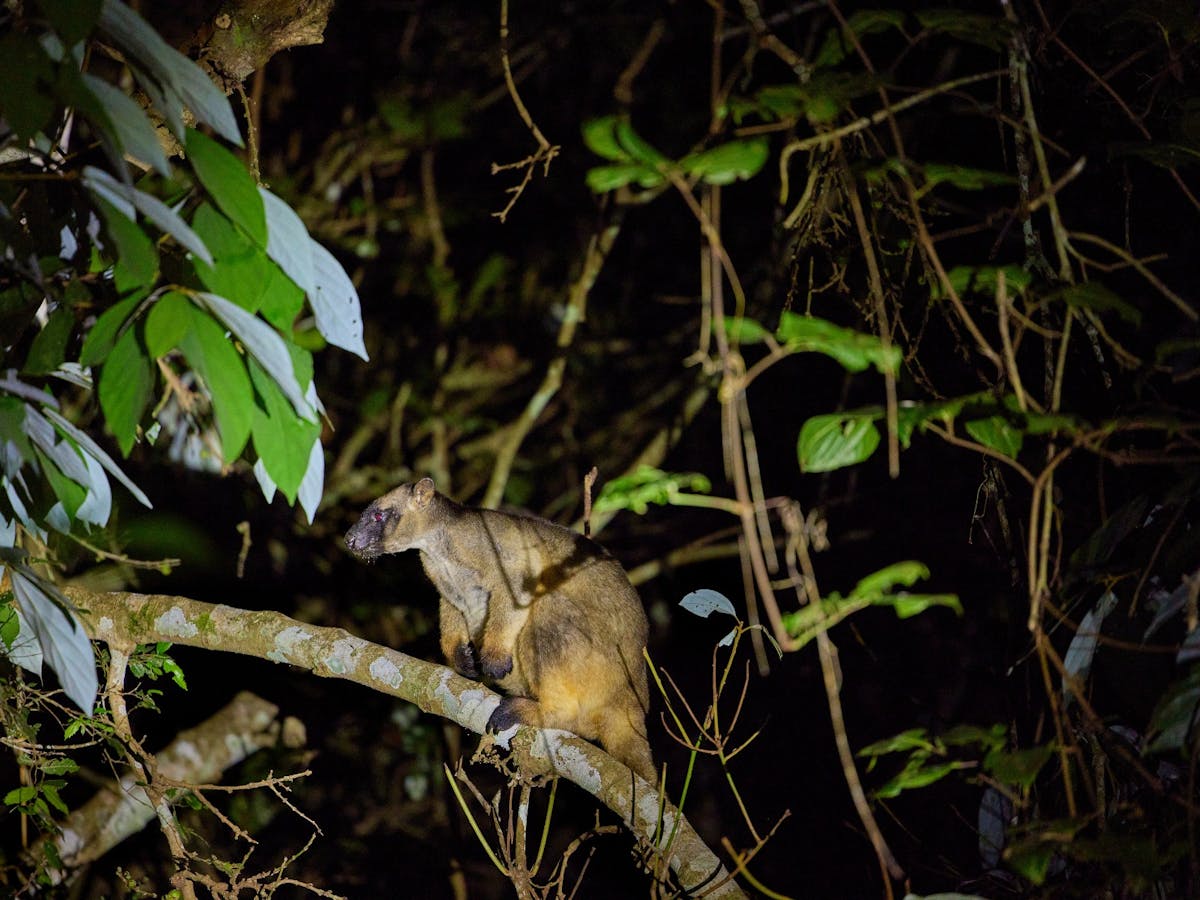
346;478;655;782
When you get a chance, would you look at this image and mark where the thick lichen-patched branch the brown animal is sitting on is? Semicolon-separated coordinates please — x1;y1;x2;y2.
65;588;744;898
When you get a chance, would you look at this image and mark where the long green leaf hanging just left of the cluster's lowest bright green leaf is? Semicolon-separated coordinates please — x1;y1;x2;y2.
179;304;254;463
